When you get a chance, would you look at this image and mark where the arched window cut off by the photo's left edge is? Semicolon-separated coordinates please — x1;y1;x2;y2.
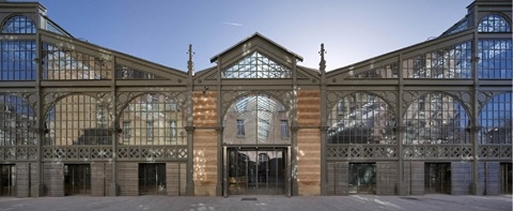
0;95;37;146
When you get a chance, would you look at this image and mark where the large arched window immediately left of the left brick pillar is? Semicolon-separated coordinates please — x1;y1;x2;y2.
118;93;187;145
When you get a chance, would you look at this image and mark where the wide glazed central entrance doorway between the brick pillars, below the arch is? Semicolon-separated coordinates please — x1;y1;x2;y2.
225;147;287;195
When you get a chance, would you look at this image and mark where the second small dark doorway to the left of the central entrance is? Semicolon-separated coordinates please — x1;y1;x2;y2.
64;164;91;196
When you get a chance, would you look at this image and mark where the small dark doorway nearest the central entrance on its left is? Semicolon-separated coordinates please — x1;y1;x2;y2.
139;163;166;195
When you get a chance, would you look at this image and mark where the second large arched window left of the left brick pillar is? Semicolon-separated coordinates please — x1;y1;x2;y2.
44;94;112;146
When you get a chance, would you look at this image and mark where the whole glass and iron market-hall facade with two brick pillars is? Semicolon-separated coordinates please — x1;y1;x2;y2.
0;0;513;197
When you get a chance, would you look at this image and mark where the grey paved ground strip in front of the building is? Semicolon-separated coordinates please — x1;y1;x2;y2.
0;195;512;211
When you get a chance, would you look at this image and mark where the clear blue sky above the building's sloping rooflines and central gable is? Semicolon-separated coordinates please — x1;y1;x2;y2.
18;0;472;71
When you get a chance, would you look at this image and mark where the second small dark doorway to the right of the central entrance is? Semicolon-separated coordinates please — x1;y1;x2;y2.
424;163;451;194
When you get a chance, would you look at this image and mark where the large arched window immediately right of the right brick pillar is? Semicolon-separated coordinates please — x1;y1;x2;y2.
328;93;396;144
